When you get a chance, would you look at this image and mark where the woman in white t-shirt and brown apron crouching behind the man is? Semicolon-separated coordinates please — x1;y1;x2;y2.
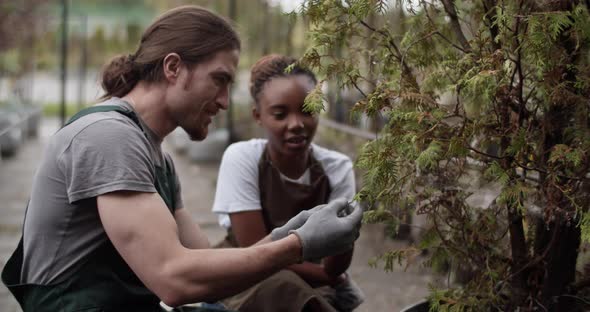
213;55;363;311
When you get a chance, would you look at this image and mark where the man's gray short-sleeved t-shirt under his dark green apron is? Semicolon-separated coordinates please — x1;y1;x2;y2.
21;98;182;285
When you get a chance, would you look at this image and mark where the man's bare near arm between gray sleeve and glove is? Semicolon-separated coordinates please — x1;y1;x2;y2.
97;192;301;306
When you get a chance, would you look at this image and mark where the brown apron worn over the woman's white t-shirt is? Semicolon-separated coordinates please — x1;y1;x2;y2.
219;148;336;312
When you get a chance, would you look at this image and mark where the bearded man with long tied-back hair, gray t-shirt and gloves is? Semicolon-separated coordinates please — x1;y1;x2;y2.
2;6;362;312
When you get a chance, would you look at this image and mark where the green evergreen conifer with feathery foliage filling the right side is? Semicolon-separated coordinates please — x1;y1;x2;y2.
302;0;590;311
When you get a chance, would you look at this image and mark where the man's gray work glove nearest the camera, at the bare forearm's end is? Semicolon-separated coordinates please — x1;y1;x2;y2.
289;198;363;261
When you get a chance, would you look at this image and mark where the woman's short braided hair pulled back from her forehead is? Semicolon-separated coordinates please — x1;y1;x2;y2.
250;54;317;103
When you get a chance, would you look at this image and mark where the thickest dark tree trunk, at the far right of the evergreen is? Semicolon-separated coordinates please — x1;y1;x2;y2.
534;1;585;312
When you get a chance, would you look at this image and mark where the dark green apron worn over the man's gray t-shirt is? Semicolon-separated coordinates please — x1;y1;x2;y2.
2;105;176;312
